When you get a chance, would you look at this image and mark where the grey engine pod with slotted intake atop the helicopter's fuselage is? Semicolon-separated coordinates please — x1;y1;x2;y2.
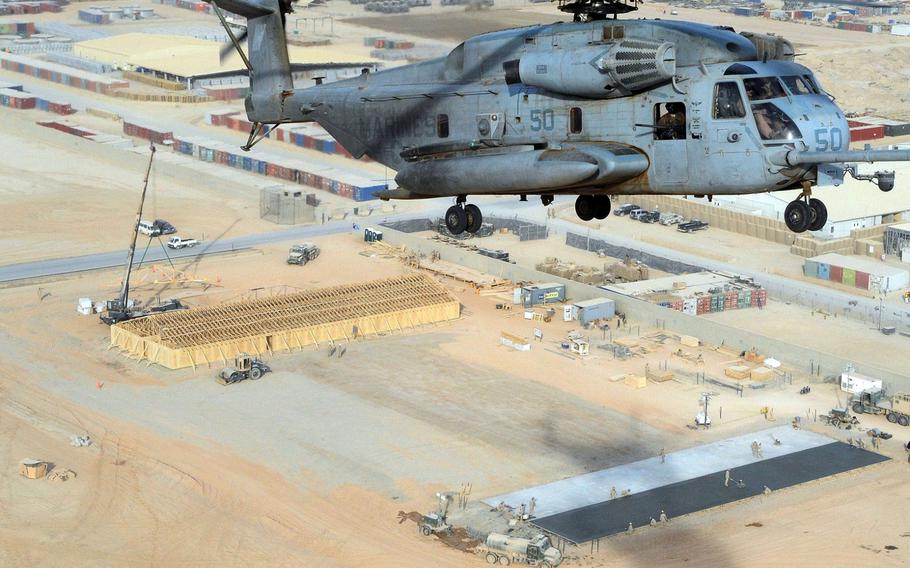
503;39;676;99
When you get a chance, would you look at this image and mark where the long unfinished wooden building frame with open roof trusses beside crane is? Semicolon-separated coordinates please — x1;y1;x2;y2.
111;273;461;369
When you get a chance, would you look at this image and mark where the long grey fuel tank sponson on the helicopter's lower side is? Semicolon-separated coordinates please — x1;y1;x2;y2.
390;144;649;198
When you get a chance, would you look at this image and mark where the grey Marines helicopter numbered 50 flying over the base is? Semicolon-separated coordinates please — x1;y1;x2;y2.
211;0;910;234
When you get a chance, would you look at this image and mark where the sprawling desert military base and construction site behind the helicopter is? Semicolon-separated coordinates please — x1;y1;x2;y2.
0;0;910;568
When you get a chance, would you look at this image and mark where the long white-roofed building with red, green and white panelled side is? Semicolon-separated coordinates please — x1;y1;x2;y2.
803;253;910;293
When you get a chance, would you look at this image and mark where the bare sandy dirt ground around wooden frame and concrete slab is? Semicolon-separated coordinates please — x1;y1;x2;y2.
0;235;910;566
